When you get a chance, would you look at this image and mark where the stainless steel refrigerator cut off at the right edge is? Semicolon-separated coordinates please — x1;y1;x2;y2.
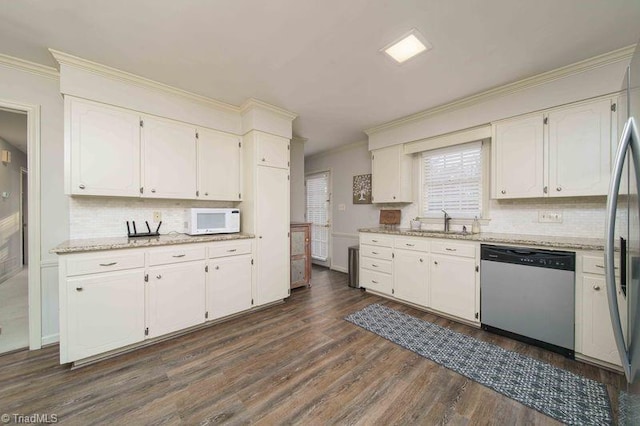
605;39;640;425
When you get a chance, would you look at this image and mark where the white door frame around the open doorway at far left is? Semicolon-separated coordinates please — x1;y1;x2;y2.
0;99;42;350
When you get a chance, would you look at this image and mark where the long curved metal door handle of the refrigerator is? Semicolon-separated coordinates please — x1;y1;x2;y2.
604;117;640;383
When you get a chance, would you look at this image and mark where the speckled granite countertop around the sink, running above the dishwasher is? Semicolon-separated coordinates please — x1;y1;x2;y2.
358;228;604;250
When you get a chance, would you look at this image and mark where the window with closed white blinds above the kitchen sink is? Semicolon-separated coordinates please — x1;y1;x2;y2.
422;142;482;218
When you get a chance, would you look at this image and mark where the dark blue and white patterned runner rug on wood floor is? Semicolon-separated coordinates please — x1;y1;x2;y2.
345;304;613;425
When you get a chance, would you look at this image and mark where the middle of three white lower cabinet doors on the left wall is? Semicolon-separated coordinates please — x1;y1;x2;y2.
146;261;206;337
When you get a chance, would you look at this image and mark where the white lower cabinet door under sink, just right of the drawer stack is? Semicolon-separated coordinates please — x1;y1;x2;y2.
393;250;429;306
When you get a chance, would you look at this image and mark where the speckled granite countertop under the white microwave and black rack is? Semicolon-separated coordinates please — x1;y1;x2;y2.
49;232;255;254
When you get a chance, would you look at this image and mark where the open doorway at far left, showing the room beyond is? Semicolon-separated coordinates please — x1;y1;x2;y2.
0;109;29;353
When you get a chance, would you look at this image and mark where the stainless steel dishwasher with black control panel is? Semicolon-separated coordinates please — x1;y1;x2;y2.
480;244;576;358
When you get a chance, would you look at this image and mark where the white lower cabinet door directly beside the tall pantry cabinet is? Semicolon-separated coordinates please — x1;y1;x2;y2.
207;255;252;320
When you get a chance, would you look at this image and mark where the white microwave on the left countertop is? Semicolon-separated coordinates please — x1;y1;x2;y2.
184;208;240;235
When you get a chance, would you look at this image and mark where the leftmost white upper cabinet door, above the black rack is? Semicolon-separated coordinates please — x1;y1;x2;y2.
66;98;140;197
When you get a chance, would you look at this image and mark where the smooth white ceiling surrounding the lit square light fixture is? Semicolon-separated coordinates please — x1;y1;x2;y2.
0;0;640;154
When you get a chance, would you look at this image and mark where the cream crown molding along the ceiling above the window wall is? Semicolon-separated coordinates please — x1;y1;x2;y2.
364;45;636;136
